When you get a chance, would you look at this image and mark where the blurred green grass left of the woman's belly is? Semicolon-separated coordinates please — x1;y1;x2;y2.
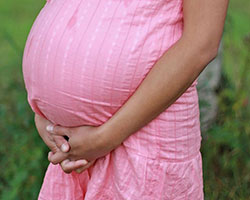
0;0;48;200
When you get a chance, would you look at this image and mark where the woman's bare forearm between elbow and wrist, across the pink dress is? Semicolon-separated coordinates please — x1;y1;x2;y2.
99;37;216;146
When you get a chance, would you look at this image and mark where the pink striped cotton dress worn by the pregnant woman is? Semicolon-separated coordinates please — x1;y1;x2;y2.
23;0;203;200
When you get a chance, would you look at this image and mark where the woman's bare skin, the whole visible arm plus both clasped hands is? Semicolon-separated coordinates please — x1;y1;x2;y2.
36;0;229;173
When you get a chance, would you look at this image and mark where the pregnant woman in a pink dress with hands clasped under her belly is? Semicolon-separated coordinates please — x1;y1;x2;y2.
23;0;228;200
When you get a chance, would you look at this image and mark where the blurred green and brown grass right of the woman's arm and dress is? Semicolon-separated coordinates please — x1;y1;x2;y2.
202;0;250;200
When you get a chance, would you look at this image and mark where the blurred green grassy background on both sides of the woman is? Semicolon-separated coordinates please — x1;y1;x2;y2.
0;0;250;200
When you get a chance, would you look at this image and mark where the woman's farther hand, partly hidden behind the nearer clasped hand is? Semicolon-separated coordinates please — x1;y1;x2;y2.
35;114;90;173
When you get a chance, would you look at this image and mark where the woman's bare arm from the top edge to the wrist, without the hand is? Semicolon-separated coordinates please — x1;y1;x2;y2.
99;0;228;147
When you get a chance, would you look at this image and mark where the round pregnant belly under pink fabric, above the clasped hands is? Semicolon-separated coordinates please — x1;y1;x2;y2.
23;0;188;126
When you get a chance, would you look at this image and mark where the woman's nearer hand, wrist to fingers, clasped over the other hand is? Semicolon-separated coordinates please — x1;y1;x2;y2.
48;122;115;173
